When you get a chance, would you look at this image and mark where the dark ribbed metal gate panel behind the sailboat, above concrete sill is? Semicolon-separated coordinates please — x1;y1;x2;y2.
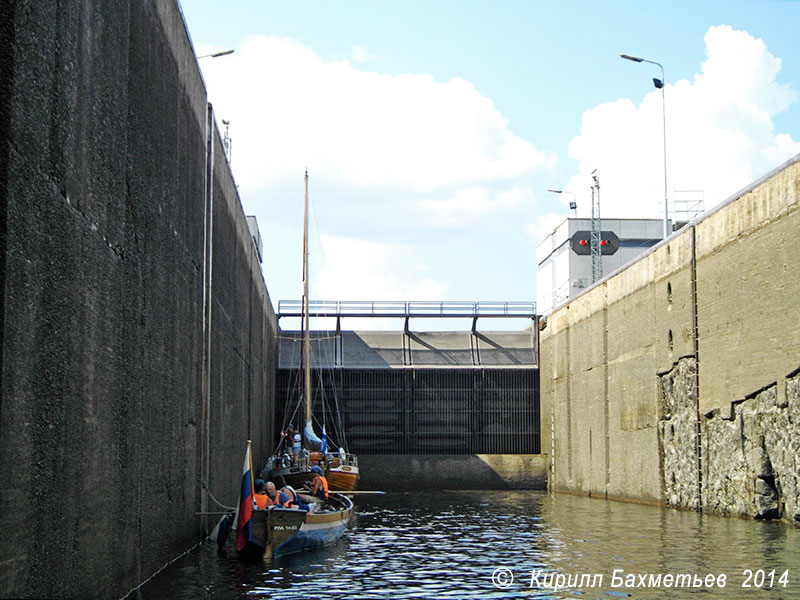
277;368;541;454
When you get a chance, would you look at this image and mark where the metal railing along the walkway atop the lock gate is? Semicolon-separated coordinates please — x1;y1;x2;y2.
278;300;536;319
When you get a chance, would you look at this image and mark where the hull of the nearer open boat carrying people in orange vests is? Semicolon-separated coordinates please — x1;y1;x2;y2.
252;494;353;558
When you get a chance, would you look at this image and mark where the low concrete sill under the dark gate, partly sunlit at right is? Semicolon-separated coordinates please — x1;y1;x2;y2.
358;454;547;492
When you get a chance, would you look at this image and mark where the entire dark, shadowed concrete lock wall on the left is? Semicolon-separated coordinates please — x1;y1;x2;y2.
0;0;277;598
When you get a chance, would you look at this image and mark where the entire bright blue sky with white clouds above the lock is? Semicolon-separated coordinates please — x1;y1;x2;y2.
181;0;800;326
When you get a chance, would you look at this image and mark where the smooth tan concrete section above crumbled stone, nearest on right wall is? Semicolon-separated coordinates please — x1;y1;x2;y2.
697;162;800;414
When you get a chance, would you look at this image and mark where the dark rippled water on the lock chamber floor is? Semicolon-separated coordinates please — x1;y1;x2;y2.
133;492;800;600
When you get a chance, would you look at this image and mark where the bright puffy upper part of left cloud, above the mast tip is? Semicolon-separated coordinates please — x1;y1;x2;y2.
198;36;555;210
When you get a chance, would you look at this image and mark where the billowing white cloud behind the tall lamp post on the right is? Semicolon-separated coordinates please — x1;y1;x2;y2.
569;26;800;218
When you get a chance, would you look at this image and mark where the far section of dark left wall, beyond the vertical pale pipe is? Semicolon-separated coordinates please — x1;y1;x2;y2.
207;120;278;525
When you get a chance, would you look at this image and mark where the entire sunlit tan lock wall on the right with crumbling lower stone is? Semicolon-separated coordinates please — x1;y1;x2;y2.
541;157;800;521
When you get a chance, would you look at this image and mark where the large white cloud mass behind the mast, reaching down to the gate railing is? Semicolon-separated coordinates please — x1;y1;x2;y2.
201;36;556;312
